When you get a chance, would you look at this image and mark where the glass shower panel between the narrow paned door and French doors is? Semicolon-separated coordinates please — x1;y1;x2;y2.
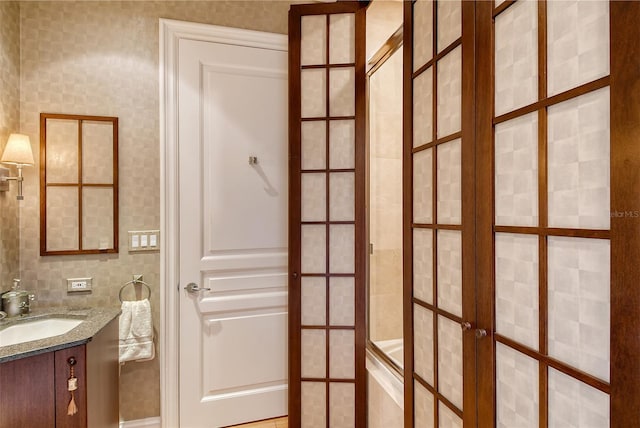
368;47;403;370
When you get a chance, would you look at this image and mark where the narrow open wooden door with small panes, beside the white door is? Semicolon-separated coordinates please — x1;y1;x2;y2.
289;2;367;428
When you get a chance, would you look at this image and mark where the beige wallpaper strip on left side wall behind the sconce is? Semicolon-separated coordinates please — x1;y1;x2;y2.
0;2;20;293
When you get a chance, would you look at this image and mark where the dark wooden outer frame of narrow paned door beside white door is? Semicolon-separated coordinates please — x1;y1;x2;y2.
289;1;369;427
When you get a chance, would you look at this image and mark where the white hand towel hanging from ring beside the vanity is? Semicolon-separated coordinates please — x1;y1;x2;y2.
120;299;155;364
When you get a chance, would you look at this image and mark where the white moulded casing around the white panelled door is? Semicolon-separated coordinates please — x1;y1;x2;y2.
158;19;288;427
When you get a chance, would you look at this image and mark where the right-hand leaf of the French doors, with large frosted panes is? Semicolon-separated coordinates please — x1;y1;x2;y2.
476;0;640;428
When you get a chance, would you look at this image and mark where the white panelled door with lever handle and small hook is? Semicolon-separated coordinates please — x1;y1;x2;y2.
178;31;287;428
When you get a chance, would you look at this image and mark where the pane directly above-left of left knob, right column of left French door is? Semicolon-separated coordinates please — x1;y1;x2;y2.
437;230;462;316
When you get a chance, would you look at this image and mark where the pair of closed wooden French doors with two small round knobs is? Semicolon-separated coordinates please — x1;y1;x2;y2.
404;0;640;428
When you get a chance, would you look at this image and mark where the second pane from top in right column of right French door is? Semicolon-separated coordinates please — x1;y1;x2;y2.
547;88;611;229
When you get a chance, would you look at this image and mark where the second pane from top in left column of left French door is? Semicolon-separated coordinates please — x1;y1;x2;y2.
413;67;433;147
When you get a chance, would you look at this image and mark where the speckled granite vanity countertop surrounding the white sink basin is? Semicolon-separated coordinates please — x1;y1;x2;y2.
0;307;120;363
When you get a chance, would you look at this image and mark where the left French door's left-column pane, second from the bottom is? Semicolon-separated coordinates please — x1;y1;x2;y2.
413;304;435;386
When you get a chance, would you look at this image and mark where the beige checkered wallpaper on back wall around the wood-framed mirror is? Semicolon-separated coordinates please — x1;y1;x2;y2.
17;1;290;420
